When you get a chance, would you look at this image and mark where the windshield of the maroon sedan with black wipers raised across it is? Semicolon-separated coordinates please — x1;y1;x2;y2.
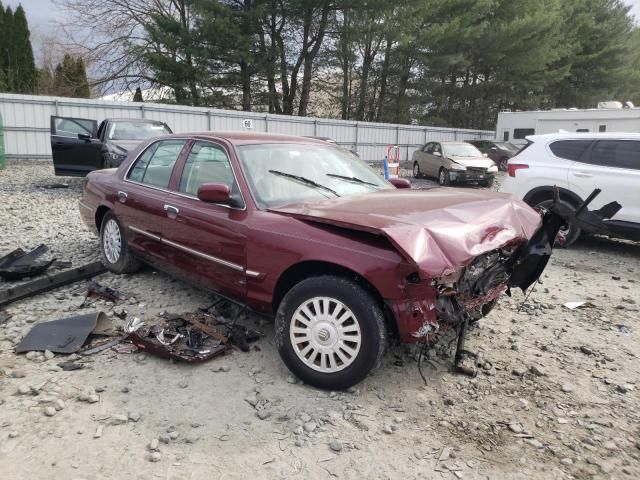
237;143;394;208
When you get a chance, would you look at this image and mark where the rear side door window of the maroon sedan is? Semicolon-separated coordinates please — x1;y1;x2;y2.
127;140;186;189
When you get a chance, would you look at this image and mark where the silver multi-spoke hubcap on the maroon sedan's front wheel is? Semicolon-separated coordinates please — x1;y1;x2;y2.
289;297;362;373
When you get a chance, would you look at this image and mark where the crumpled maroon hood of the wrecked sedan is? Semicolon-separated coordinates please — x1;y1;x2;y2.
270;188;541;278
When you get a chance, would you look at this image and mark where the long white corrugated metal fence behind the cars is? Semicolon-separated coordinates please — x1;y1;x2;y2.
0;94;495;162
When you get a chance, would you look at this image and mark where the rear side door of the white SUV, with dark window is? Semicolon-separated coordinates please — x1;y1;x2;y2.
569;140;640;223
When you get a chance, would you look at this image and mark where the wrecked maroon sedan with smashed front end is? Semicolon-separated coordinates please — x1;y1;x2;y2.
80;133;555;389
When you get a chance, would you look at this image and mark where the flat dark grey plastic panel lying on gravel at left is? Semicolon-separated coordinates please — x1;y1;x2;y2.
16;312;112;353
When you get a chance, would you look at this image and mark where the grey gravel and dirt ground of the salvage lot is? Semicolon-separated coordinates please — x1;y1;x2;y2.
0;162;640;479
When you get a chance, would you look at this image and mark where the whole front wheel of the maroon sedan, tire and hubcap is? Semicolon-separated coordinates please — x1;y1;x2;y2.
275;275;386;390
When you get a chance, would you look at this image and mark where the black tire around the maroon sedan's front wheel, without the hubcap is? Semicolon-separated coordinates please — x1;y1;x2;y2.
275;275;387;390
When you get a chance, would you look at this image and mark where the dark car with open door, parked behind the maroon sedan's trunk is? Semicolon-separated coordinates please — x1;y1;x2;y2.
51;116;172;177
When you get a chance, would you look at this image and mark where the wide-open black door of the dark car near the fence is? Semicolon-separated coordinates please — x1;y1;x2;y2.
51;116;102;177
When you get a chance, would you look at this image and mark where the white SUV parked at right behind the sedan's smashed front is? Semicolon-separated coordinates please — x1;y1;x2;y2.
500;133;640;246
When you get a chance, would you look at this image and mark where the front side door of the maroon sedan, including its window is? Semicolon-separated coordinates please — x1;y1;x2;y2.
162;141;246;300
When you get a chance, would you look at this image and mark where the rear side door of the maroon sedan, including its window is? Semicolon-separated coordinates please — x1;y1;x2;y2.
114;139;186;263
